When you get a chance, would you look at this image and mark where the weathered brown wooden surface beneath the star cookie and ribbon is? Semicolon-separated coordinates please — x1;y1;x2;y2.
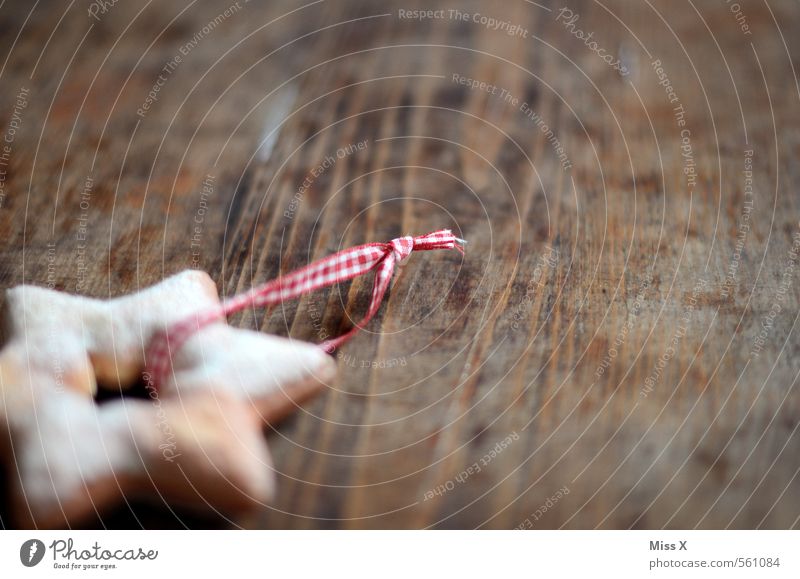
0;0;800;528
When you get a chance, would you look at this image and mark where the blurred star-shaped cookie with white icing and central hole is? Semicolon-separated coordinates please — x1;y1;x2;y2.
0;270;336;528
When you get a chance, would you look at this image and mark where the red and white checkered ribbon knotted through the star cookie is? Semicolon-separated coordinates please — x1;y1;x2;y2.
145;229;466;387
